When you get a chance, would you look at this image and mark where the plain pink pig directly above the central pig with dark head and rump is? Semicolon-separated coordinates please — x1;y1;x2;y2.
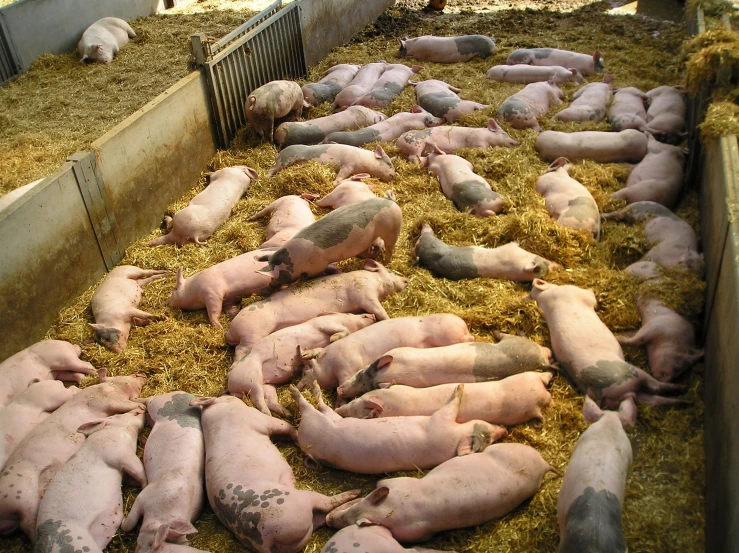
298;313;475;390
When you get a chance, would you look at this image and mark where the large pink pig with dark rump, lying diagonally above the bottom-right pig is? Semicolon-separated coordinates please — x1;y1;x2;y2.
531;279;685;408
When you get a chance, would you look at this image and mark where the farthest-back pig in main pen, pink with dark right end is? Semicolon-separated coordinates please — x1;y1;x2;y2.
398;35;495;63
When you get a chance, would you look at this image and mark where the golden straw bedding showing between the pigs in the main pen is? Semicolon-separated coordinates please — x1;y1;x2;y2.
3;3;704;553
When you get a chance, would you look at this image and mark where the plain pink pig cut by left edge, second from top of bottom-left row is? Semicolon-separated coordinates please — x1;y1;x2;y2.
0;379;79;468
